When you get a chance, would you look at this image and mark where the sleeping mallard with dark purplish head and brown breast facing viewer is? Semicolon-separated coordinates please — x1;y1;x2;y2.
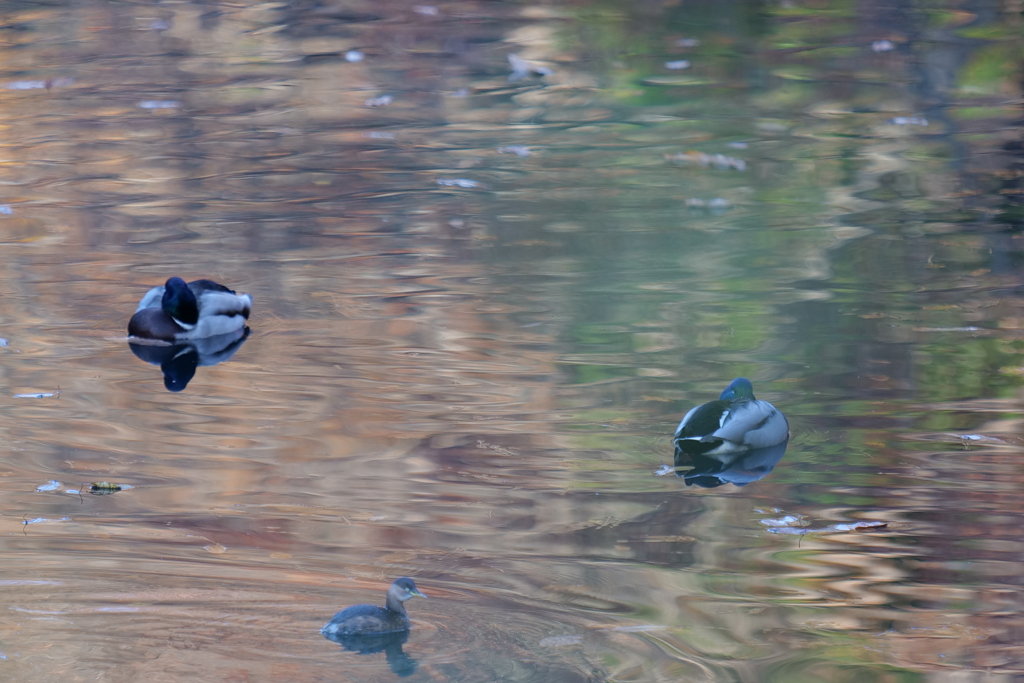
128;278;253;342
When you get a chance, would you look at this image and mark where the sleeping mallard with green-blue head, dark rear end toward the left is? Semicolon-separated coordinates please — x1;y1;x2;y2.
675;377;790;458
